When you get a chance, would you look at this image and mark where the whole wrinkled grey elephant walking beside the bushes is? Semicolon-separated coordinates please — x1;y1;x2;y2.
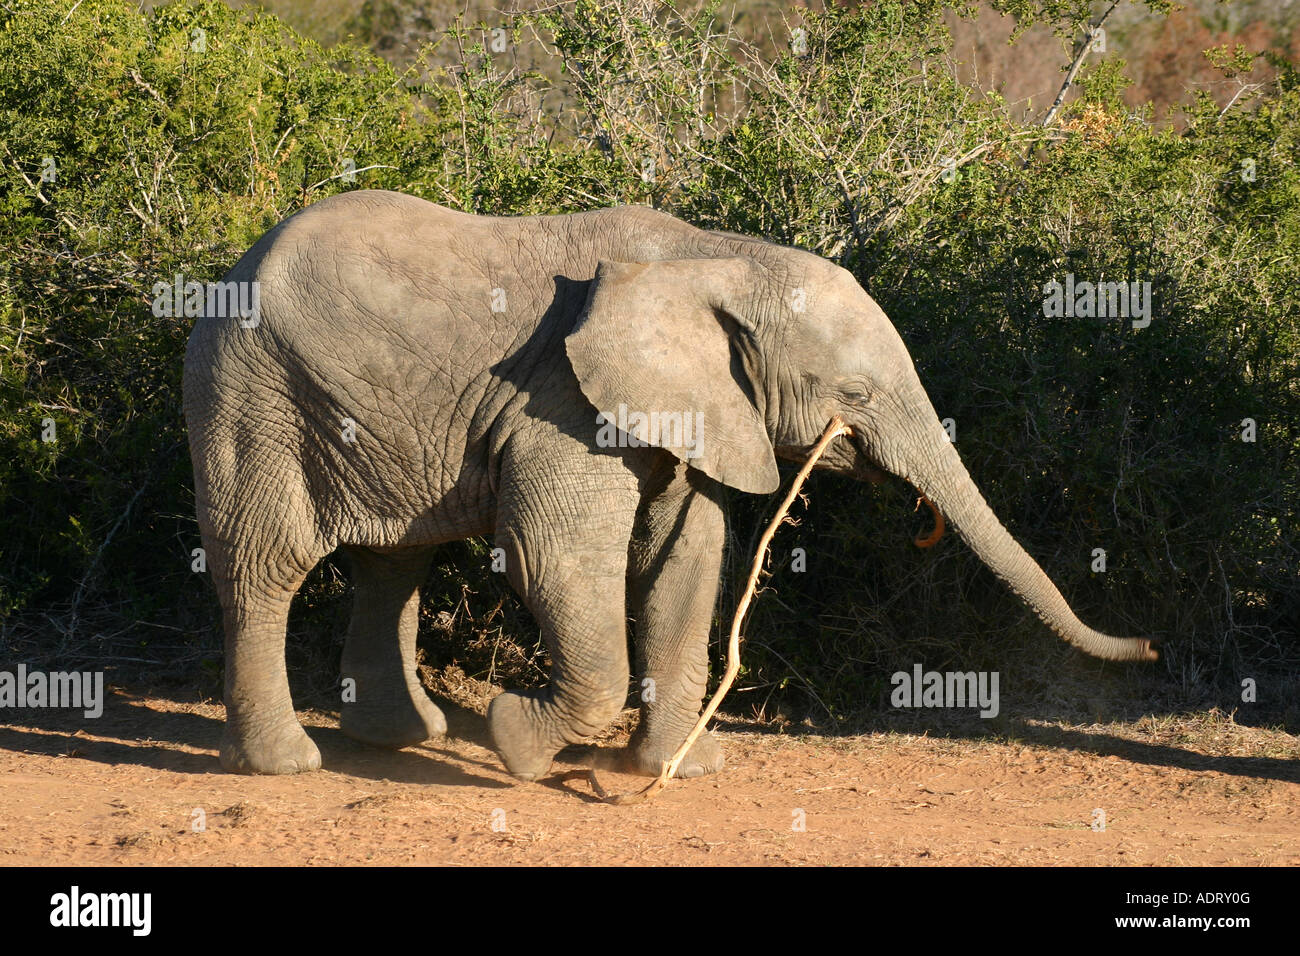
185;191;1153;780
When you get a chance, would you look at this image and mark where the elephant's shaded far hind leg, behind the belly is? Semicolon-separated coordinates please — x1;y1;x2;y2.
341;548;447;748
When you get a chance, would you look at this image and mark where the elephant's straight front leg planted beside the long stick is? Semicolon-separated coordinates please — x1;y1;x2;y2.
629;464;725;777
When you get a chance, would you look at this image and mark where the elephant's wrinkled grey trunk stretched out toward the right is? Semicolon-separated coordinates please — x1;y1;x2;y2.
883;382;1157;661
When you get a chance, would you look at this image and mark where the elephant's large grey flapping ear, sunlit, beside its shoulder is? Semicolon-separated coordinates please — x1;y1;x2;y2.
567;259;780;494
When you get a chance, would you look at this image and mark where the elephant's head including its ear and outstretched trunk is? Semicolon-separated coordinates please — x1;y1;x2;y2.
567;251;1156;661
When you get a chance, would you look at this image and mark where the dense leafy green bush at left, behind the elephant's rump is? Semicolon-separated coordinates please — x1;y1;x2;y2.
0;0;438;661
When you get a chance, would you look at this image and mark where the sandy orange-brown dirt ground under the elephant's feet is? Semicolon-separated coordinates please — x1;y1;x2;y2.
0;688;1300;866
